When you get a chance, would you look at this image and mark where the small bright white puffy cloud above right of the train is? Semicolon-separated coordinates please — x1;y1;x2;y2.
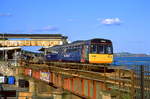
101;18;121;25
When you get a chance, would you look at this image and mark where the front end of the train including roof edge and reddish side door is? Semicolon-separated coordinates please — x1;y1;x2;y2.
81;39;113;63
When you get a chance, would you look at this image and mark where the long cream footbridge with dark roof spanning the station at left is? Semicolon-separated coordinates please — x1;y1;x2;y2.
0;34;68;47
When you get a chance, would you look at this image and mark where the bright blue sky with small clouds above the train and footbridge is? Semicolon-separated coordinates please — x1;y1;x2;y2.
0;0;150;54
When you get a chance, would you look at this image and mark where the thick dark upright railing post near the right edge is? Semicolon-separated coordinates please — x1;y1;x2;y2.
141;65;144;99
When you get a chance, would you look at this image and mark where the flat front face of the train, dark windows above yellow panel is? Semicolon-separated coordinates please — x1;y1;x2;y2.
89;40;113;63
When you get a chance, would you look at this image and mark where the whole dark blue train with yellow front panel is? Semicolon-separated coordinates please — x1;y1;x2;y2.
45;38;113;64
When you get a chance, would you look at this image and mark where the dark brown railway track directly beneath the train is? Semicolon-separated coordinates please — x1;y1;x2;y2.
21;61;124;72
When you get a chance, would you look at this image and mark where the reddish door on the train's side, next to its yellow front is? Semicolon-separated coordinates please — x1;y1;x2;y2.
81;45;89;63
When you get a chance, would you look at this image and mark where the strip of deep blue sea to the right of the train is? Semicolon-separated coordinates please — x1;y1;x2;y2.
113;57;150;66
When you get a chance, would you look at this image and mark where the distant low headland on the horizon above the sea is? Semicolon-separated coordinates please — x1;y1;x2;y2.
114;52;150;57
